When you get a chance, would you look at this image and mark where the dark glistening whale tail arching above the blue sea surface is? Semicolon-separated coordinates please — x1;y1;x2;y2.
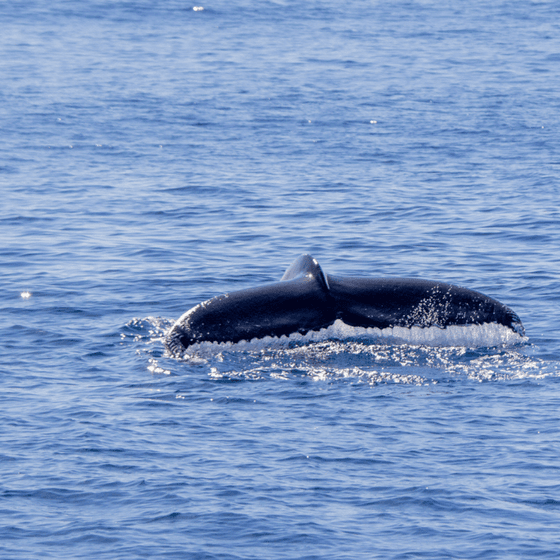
165;255;525;355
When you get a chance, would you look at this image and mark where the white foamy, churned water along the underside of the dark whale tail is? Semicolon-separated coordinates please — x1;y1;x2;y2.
121;317;558;385
